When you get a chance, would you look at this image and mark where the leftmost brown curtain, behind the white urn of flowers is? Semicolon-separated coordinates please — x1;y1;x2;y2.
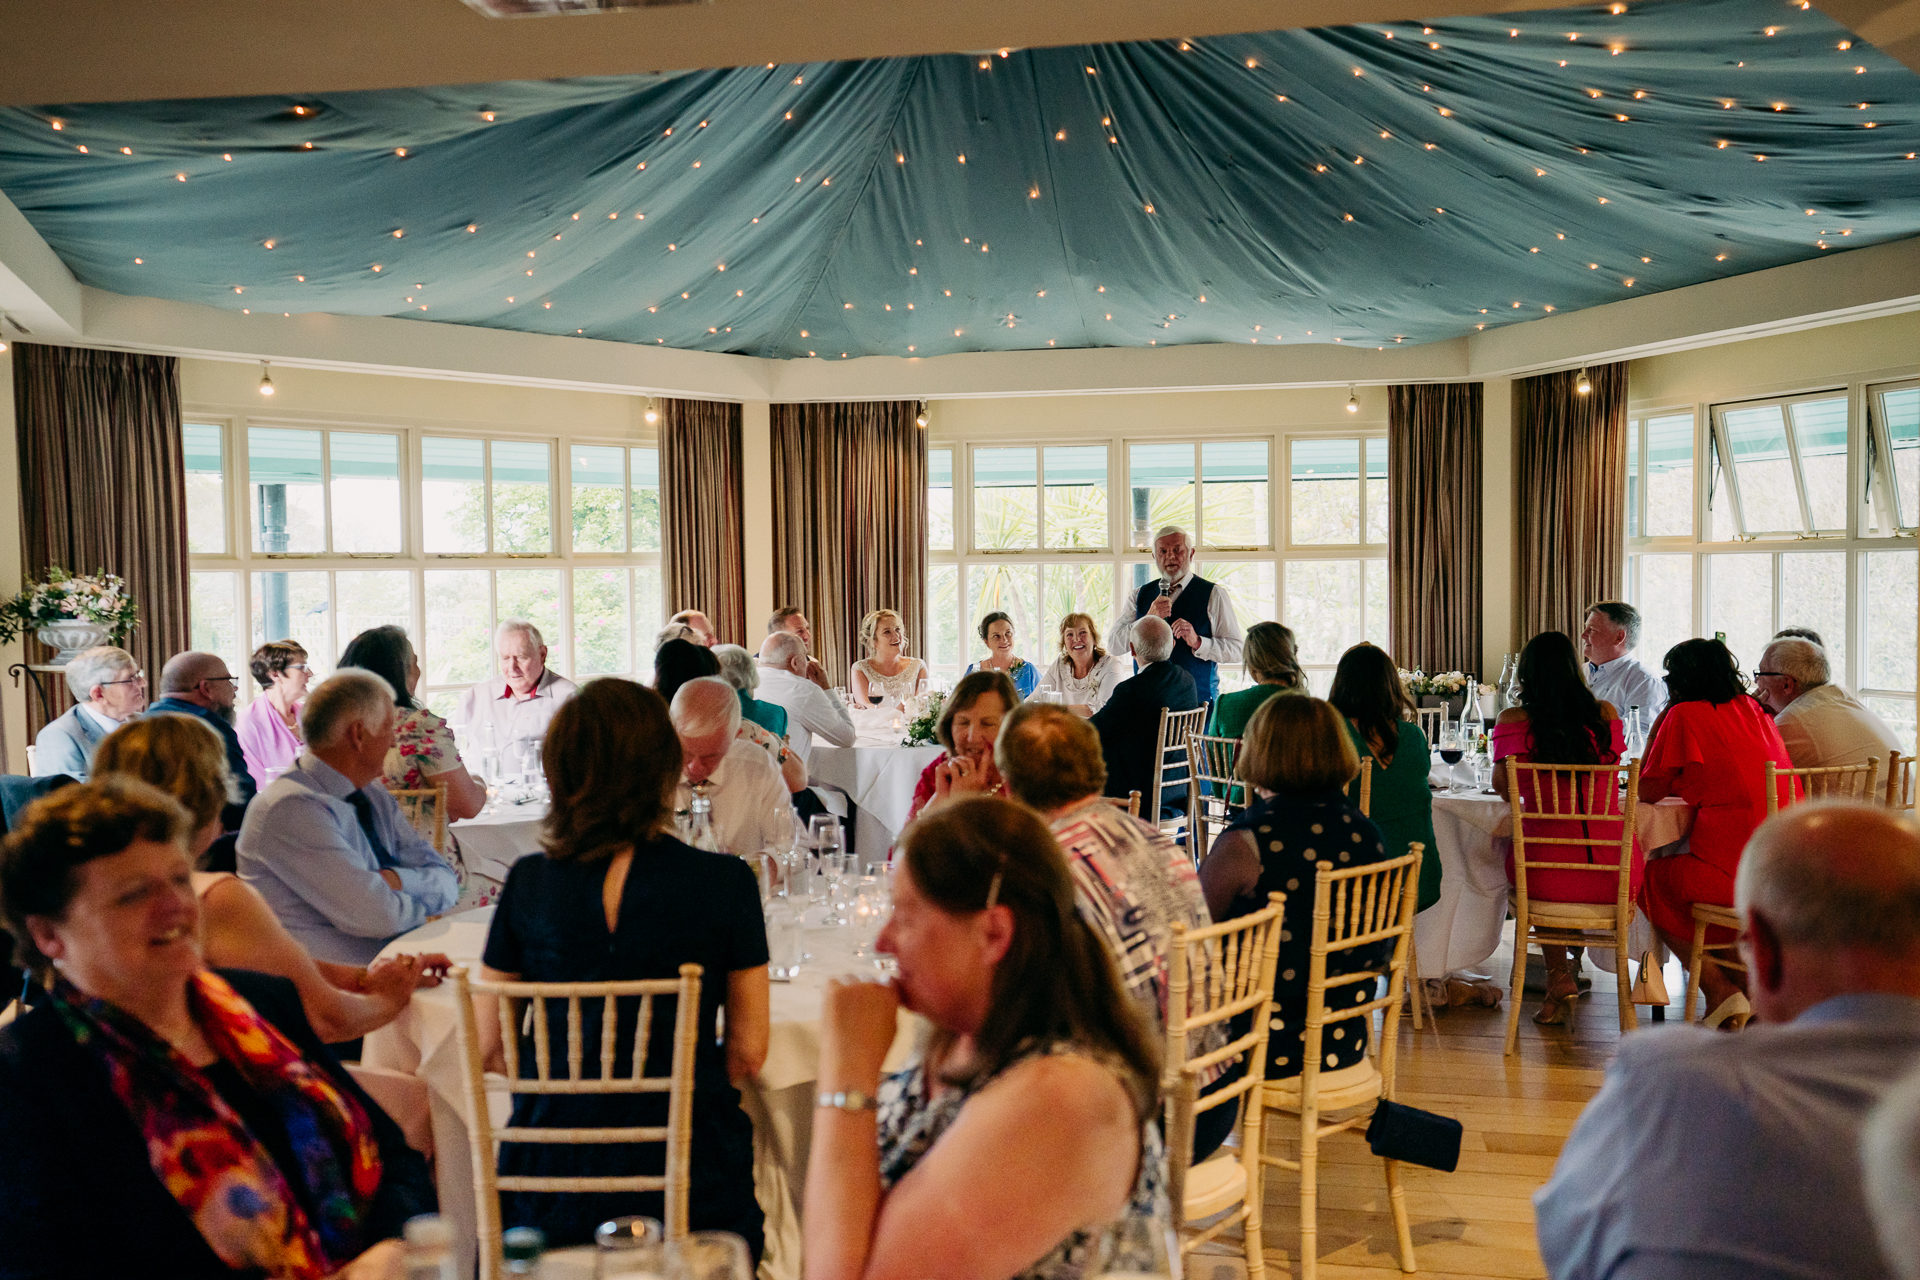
13;342;192;739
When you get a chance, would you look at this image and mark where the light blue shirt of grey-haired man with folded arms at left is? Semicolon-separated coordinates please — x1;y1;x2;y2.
236;752;461;965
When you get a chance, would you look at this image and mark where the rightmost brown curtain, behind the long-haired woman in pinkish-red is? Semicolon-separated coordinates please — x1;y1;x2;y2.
1513;363;1626;643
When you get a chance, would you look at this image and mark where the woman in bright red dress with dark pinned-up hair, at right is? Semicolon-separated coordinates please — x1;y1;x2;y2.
1640;639;1799;1013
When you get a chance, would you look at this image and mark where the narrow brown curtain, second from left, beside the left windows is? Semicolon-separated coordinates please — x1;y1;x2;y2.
660;399;747;645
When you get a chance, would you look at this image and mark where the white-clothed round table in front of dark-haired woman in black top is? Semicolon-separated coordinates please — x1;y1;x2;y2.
361;901;924;1280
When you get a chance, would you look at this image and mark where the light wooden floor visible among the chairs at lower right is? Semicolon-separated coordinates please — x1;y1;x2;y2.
1187;923;1684;1280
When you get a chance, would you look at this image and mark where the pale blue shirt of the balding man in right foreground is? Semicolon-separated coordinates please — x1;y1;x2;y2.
1534;994;1920;1280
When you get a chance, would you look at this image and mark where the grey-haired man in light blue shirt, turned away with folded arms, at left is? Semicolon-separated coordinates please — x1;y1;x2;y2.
236;668;461;965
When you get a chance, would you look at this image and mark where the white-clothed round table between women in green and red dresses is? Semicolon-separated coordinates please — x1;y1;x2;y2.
1413;766;1693;979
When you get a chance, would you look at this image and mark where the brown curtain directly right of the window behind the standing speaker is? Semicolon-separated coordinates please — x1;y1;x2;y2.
1386;382;1486;672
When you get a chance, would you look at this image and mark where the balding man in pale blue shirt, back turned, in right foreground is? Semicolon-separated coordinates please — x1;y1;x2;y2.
1534;802;1920;1280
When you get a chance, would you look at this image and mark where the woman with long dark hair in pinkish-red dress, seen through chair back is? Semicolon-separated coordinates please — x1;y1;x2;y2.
1490;631;1645;1027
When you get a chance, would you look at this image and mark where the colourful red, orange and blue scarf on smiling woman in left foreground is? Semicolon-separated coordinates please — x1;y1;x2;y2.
54;969;380;1280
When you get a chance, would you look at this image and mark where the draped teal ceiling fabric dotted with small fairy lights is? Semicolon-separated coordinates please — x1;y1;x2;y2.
0;0;1920;359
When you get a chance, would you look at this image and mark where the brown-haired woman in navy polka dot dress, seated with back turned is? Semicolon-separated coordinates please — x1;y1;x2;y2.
1200;699;1386;1080
